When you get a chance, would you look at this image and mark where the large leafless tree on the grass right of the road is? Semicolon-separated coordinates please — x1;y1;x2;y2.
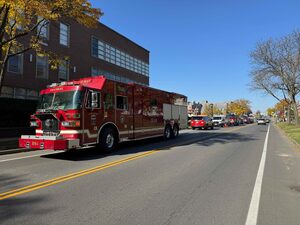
250;31;300;125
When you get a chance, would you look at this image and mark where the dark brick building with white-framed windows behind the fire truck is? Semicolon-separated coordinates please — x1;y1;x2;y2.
0;20;149;128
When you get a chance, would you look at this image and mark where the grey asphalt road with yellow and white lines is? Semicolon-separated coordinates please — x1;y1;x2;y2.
0;125;300;225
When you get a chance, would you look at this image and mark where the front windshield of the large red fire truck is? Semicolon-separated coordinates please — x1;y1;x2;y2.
38;91;82;110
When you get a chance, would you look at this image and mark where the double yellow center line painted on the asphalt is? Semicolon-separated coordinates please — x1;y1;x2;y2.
0;150;159;200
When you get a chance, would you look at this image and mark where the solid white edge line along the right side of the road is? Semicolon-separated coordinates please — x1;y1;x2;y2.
245;125;270;225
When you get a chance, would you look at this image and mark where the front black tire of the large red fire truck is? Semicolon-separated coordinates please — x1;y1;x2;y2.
98;127;117;153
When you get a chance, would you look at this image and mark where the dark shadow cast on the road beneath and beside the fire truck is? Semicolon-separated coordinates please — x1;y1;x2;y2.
41;130;256;161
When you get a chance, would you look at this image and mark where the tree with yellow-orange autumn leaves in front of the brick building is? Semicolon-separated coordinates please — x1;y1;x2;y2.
0;0;102;93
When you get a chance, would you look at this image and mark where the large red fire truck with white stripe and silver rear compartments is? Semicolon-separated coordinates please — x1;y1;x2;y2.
19;76;187;152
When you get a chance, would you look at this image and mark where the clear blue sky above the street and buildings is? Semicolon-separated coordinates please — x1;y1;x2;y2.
91;0;300;112
